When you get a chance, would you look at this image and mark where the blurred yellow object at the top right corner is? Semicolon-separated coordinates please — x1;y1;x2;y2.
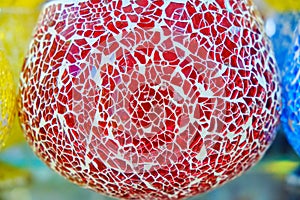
265;0;300;12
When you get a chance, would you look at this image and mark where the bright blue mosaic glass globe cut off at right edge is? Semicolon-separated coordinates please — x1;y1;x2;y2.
281;22;300;155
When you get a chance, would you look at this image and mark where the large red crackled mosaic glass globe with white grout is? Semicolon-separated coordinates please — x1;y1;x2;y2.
20;0;280;199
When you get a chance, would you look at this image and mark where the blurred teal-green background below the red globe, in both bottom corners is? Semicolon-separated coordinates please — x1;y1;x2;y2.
0;129;300;200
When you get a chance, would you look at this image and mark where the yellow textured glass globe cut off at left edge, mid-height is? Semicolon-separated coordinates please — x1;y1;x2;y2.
0;52;16;148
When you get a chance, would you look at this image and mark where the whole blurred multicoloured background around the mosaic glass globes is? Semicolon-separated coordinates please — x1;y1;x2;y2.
0;0;300;200
